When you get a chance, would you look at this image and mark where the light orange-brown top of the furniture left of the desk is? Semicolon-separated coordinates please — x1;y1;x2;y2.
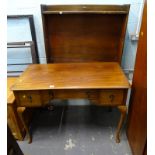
7;77;18;104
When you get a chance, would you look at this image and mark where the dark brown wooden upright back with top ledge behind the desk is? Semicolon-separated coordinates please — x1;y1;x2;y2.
41;5;130;63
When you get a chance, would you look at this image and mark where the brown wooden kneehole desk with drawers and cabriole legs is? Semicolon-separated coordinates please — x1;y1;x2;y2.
12;62;130;142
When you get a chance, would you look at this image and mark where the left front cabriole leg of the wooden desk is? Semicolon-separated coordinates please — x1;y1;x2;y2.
17;107;32;144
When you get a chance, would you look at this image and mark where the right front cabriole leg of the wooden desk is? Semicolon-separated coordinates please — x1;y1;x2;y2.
116;105;127;143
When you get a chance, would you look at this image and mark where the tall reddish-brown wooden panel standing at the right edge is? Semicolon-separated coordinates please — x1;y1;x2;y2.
127;2;147;155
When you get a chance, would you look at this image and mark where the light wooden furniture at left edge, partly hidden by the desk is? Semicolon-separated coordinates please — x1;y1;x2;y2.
7;77;32;140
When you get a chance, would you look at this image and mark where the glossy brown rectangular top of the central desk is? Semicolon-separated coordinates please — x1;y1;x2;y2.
12;62;130;90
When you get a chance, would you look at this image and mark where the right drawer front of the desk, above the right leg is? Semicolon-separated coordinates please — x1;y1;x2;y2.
99;90;124;105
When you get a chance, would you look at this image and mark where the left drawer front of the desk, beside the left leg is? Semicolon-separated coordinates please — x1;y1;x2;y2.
15;91;42;107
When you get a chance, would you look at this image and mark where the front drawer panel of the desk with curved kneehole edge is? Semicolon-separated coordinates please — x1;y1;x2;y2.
14;89;127;107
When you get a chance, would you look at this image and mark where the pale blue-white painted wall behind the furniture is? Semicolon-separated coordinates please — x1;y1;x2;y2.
7;0;143;69
